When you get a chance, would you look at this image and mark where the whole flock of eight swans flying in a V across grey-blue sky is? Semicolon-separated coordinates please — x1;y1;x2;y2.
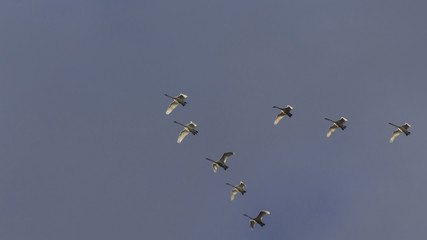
165;93;412;230
